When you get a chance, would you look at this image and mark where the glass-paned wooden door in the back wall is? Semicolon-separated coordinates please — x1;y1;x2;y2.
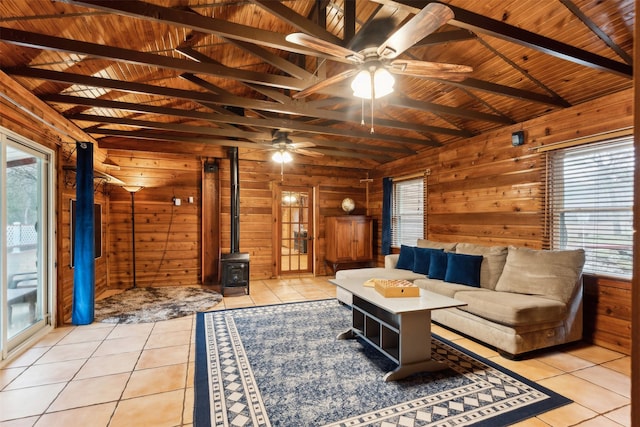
279;189;313;274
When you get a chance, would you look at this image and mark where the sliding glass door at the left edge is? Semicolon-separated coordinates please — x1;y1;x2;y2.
0;129;53;358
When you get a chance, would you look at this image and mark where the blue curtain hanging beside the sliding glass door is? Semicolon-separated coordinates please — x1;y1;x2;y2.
71;142;95;325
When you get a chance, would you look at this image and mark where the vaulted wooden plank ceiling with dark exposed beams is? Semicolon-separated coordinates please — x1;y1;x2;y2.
0;0;635;167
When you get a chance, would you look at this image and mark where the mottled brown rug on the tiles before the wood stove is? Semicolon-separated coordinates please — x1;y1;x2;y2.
95;286;222;323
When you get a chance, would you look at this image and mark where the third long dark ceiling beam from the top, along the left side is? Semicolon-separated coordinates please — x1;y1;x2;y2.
11;68;456;138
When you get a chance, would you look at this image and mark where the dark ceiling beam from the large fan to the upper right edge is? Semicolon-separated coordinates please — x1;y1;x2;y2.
385;0;633;79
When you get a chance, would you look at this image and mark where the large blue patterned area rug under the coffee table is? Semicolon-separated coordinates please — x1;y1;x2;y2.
194;300;571;427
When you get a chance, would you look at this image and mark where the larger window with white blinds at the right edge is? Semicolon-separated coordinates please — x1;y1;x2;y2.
549;137;634;278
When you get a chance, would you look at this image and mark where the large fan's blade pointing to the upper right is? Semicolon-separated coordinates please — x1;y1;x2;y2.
378;3;454;59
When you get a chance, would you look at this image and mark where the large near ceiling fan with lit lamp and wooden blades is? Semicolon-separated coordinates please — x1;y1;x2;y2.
286;3;473;99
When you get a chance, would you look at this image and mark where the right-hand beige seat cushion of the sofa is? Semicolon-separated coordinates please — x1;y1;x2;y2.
455;291;567;326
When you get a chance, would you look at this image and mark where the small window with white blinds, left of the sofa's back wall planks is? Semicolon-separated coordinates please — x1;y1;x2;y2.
391;177;424;247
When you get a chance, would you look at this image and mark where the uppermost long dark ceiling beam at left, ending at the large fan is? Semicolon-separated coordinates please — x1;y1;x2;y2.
65;0;348;62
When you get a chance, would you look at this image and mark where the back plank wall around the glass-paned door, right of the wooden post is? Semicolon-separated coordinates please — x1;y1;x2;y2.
219;155;366;279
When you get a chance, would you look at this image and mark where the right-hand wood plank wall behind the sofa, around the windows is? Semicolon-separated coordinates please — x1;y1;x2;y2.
371;90;633;354
